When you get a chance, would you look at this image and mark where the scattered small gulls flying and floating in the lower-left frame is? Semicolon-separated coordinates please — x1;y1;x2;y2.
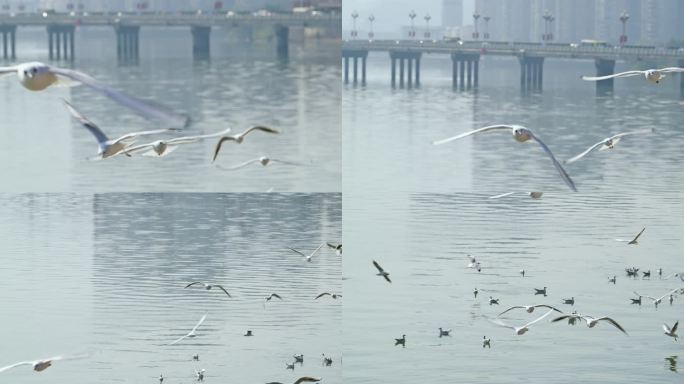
0;242;342;384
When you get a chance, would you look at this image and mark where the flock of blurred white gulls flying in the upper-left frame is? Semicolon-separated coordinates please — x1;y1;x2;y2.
0;62;302;171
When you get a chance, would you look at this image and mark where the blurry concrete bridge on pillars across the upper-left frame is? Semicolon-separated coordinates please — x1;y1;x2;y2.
0;13;341;60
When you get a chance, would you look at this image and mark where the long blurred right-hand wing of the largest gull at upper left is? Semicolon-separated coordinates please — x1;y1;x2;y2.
50;67;189;128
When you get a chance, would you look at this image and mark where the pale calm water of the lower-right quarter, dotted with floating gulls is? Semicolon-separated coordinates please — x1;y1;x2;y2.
344;191;684;383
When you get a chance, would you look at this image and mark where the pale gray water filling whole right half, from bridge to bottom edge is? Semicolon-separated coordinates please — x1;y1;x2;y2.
342;55;684;384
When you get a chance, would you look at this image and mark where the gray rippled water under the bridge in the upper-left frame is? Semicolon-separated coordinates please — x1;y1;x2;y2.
0;27;341;192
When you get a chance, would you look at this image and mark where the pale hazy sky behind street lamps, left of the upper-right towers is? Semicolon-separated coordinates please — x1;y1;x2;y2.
342;0;475;32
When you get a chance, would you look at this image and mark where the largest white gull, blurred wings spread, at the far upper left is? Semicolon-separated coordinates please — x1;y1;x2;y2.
0;62;189;128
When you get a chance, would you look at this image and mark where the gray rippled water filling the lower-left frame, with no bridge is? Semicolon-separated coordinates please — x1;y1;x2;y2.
0;193;342;383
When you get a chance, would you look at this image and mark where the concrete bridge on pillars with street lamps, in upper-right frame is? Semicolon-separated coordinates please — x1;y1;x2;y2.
342;40;684;95
